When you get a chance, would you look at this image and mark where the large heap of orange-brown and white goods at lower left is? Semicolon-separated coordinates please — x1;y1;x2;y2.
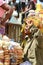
0;37;23;65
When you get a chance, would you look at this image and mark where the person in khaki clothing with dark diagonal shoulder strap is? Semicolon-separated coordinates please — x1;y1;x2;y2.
23;26;43;65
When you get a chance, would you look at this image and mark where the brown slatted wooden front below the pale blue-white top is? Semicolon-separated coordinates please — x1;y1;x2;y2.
6;23;21;42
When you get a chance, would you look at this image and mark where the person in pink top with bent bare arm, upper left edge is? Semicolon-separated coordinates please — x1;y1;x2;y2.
0;0;13;34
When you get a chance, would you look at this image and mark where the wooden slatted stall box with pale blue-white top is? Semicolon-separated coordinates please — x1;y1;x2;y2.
6;14;22;42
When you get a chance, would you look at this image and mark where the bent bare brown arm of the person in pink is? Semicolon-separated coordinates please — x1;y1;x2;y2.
0;0;13;24
